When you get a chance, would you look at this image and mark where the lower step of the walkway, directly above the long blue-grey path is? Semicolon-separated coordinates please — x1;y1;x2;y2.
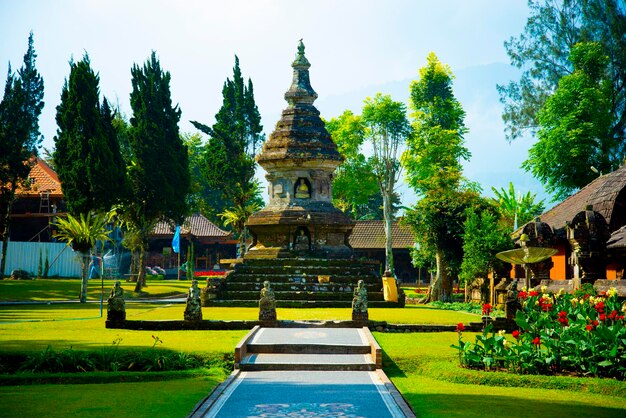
239;353;376;371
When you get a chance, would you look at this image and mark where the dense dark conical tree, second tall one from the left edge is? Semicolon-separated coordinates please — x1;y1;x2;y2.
54;55;127;216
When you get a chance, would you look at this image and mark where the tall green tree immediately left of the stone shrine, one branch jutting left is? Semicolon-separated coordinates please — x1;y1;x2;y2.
191;56;265;227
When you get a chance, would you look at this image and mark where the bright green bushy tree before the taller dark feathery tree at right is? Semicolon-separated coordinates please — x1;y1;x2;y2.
522;43;608;199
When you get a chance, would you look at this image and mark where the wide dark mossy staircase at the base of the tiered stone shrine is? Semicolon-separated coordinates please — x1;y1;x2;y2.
203;258;398;307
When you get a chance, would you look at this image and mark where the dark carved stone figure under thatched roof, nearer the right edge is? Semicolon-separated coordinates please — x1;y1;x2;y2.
567;205;611;283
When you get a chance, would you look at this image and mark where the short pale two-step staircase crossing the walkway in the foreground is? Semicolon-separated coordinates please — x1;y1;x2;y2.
235;326;381;371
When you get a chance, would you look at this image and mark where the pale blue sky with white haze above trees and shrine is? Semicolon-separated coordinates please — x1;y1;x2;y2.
0;0;546;204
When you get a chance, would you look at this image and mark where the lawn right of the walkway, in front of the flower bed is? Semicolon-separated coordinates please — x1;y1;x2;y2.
374;333;626;417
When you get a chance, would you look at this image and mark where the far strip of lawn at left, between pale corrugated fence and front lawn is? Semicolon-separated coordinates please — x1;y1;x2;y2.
0;279;191;301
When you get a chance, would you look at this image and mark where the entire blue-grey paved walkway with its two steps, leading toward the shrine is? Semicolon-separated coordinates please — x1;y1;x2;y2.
191;328;414;418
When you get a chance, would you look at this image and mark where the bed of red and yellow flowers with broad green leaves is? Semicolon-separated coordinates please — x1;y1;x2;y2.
452;288;626;380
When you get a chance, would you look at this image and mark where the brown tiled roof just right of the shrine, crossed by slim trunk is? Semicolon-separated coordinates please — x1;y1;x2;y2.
348;221;415;249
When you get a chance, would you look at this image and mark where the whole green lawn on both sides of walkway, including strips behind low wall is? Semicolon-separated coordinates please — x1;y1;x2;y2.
0;292;626;417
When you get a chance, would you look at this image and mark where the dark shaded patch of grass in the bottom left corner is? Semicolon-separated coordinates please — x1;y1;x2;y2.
0;376;220;418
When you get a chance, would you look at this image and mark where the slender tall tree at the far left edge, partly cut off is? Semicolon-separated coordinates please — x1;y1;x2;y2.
0;32;44;279
